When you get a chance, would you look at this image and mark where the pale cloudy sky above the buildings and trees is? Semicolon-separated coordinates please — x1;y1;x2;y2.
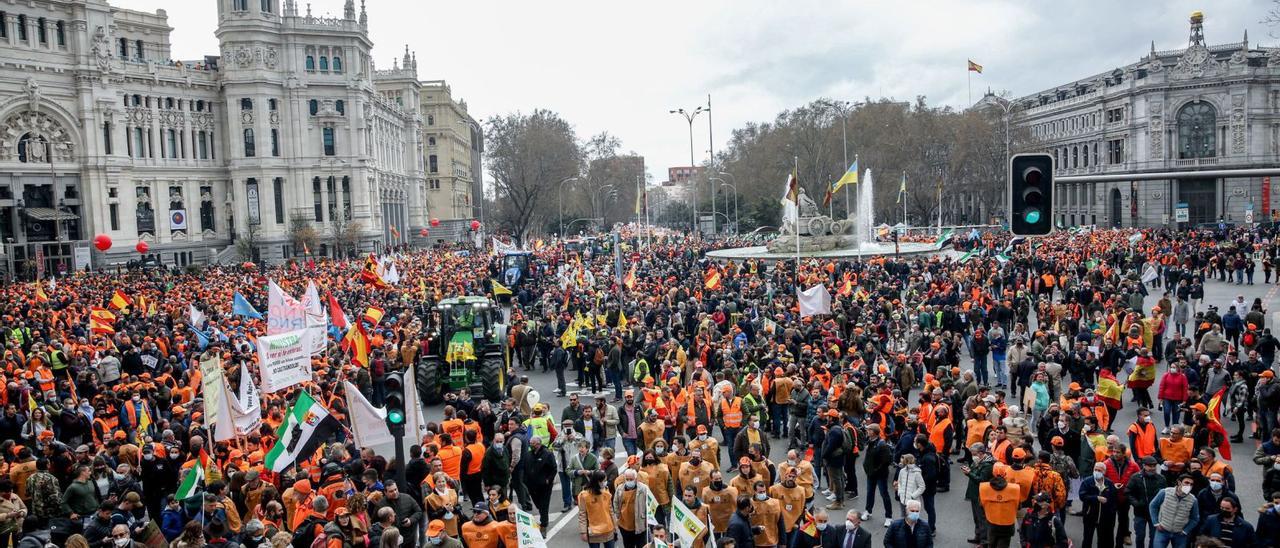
122;0;1280;182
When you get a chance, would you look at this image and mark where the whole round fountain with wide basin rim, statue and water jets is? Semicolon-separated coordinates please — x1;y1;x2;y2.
707;169;941;260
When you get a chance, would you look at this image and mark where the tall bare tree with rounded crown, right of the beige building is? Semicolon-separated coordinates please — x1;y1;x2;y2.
485;109;582;243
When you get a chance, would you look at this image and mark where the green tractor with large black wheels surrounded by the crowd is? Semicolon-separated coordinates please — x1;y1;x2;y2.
416;297;507;403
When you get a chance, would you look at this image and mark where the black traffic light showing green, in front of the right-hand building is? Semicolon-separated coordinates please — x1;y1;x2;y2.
1009;154;1053;236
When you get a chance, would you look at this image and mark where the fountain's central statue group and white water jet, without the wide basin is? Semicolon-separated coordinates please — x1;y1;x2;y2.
765;170;874;254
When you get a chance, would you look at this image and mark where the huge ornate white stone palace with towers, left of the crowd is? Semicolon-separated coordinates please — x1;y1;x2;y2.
0;0;470;274
